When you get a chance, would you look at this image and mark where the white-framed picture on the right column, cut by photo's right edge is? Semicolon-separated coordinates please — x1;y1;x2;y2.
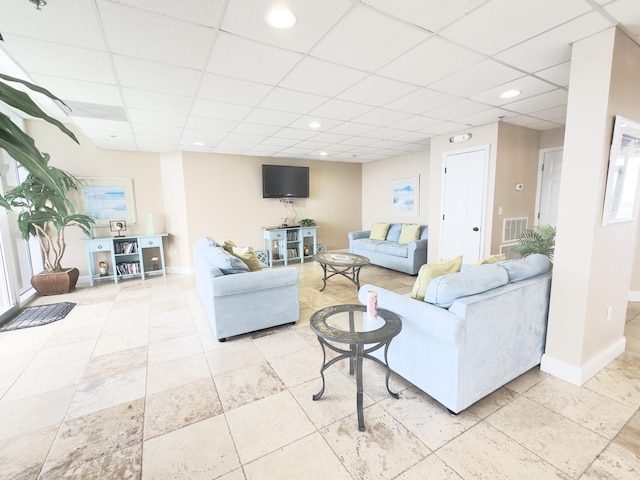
602;115;640;226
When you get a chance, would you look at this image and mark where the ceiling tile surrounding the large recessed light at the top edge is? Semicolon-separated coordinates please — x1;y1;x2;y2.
222;0;351;52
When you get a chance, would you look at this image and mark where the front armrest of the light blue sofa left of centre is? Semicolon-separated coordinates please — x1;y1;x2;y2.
211;268;299;297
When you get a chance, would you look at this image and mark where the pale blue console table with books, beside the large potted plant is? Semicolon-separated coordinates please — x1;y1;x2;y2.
85;233;168;287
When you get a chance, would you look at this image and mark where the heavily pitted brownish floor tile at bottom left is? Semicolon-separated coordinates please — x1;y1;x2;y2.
43;399;144;478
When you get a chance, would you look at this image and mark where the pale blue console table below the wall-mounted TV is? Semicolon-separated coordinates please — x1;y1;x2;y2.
264;227;318;267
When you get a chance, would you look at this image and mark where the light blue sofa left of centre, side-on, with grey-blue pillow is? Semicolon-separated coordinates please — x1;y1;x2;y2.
193;237;300;342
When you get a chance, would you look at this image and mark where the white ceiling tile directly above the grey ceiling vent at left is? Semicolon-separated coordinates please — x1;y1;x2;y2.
33;75;123;106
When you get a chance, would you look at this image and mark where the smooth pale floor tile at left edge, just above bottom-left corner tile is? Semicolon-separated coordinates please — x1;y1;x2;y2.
0;386;76;440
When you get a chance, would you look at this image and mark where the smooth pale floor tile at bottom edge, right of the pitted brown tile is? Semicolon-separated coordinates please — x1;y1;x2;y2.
142;415;240;480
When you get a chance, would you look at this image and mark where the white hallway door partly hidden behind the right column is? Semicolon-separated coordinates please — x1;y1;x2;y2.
536;148;562;227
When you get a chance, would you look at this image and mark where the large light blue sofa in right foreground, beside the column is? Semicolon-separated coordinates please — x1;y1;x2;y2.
358;254;551;413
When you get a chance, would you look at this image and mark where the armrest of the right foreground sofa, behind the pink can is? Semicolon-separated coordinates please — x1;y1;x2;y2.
358;284;465;344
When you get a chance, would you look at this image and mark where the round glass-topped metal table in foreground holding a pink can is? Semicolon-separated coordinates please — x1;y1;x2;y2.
310;305;402;432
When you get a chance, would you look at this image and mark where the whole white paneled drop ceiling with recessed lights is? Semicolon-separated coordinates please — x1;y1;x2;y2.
0;0;640;162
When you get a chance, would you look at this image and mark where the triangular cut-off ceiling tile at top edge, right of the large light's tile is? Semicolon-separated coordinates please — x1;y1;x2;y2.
362;0;486;32
